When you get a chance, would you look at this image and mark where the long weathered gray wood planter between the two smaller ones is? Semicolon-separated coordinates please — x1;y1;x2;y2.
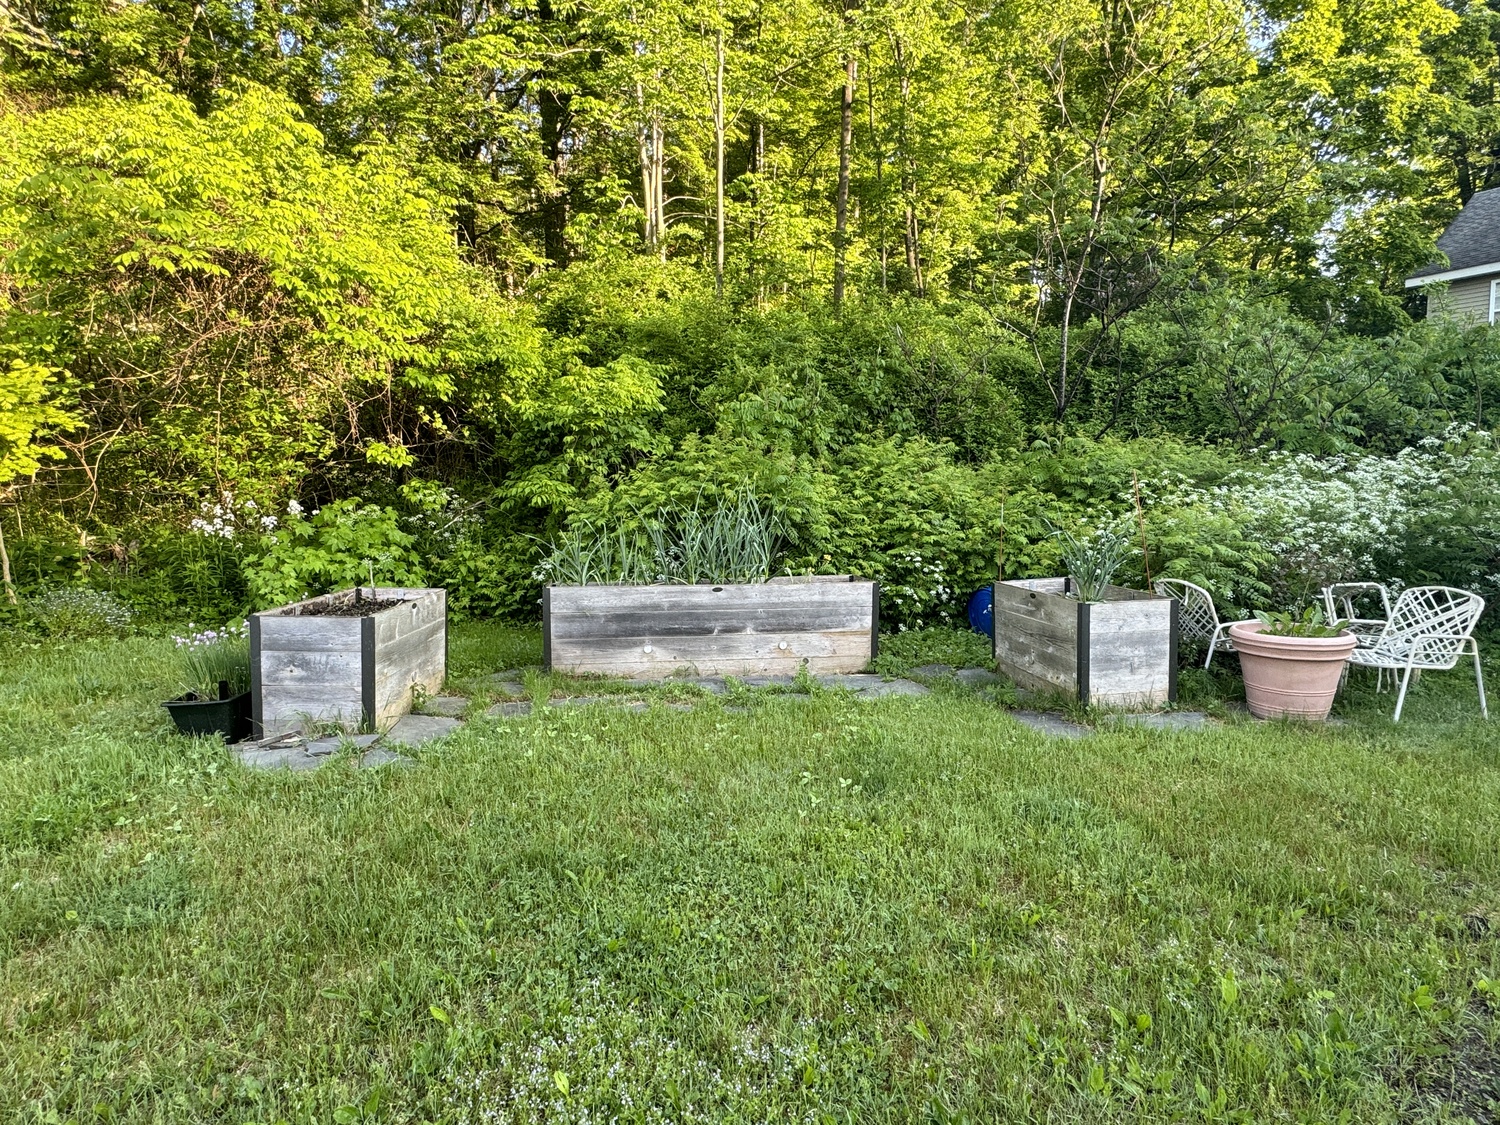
542;575;881;680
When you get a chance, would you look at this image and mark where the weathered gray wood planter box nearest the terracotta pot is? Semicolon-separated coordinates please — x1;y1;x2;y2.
995;578;1178;707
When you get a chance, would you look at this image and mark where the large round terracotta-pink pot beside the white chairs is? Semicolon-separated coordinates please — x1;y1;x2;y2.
1229;621;1356;720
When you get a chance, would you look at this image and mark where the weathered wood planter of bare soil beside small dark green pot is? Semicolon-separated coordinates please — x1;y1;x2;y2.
249;587;449;737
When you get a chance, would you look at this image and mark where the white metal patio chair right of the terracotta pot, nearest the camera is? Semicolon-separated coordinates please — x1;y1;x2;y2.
1349;587;1490;723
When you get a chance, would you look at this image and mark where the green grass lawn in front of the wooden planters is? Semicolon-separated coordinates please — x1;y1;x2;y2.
0;626;1500;1122
